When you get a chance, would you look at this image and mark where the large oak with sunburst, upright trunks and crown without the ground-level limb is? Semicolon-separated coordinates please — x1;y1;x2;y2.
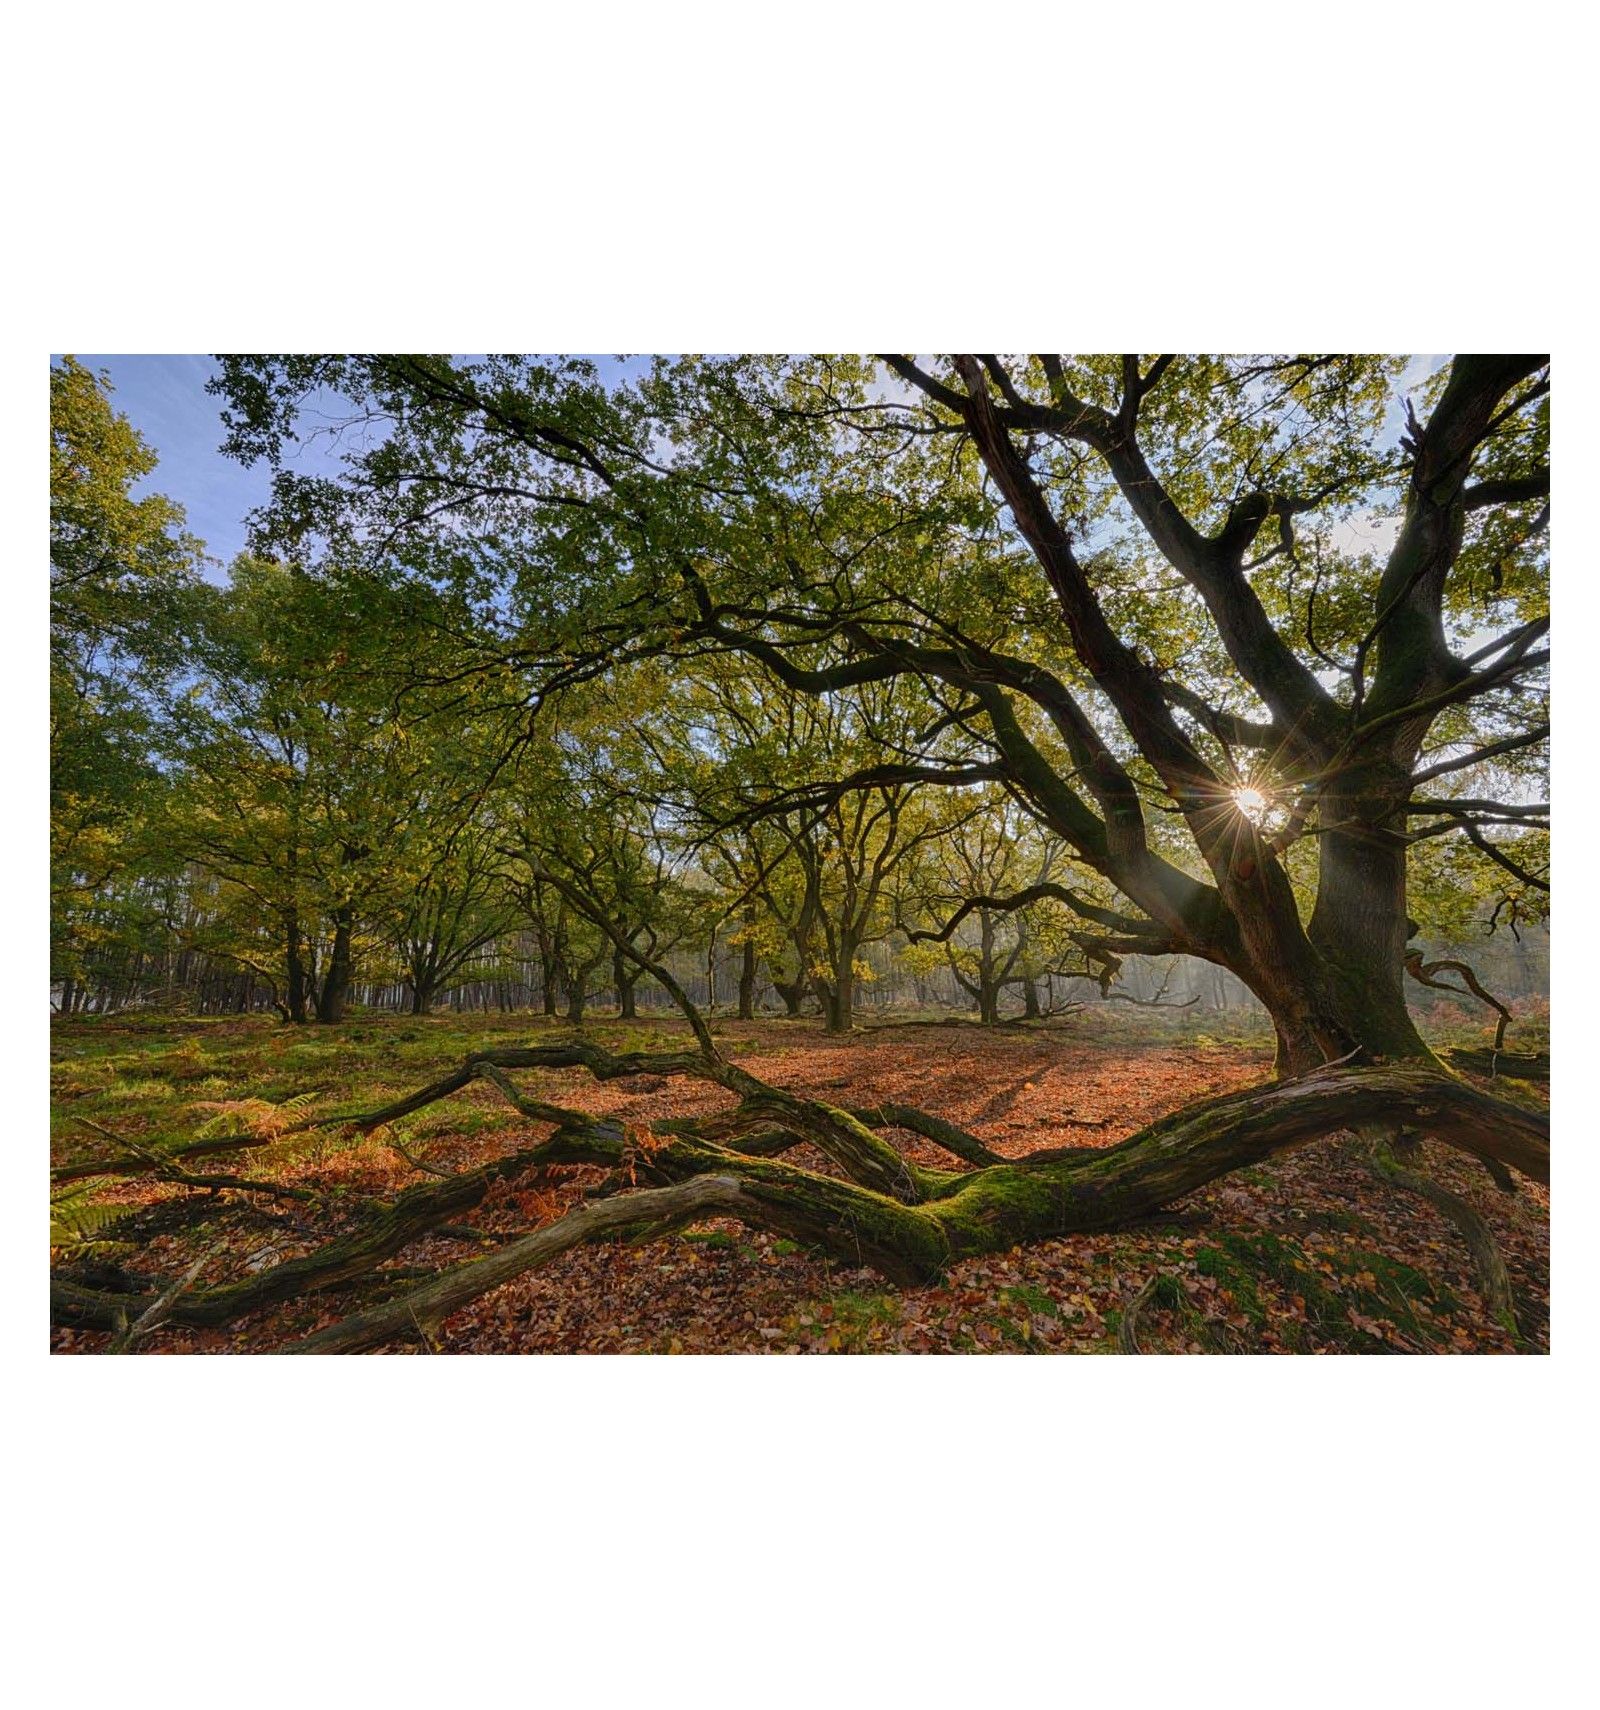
212;356;1549;1072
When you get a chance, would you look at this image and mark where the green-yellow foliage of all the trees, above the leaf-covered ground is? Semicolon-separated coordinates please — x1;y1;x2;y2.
51;354;1549;1036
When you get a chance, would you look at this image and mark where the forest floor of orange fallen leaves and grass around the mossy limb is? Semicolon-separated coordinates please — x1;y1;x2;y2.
51;1009;1549;1354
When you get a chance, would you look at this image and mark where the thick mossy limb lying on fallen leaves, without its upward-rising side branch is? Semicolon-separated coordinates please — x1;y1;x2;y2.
51;1032;1549;1349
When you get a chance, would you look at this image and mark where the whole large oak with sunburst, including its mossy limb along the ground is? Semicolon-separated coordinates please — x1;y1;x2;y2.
56;356;1549;1351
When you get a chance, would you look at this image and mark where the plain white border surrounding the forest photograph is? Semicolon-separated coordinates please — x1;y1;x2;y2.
0;0;1597;1707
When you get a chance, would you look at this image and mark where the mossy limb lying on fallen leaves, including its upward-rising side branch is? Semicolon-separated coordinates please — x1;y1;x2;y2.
51;902;1550;1351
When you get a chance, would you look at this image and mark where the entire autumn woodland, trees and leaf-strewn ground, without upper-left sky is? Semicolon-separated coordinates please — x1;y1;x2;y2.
50;354;1550;1354
